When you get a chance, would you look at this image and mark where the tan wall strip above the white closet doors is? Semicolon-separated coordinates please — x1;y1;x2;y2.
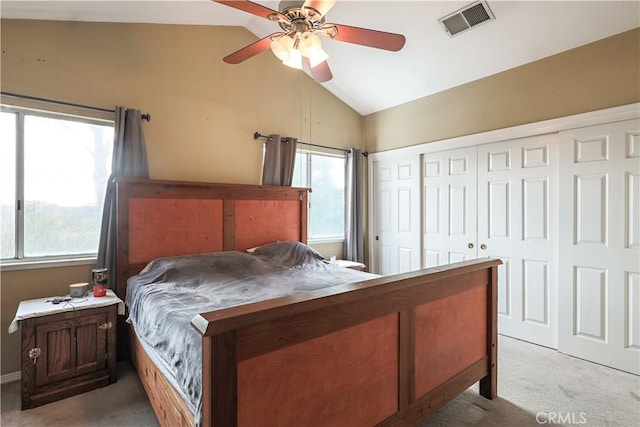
364;29;640;152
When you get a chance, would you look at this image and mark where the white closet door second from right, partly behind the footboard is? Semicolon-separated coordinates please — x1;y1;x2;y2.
478;134;558;348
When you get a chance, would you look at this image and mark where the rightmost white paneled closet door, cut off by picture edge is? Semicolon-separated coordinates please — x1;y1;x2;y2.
558;120;640;374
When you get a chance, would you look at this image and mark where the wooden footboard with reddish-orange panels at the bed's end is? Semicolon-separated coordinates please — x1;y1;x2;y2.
192;259;501;426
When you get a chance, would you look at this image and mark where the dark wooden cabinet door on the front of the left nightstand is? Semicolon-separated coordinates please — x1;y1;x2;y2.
36;313;107;386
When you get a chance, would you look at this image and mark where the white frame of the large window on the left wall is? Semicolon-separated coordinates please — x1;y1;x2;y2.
0;103;115;271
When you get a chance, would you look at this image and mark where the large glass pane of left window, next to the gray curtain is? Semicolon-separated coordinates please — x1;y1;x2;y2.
24;115;113;257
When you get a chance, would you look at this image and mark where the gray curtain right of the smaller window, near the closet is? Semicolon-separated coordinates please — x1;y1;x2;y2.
344;148;364;262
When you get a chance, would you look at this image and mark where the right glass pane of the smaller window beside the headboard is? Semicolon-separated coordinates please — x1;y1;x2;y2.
309;154;345;239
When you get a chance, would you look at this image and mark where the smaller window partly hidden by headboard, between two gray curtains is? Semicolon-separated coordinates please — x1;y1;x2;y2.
293;150;345;242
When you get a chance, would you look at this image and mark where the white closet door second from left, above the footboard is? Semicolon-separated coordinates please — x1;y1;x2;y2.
423;146;477;268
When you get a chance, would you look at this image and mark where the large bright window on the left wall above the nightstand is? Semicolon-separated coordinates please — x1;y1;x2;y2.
0;106;113;262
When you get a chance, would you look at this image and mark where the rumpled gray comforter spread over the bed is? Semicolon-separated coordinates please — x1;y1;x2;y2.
126;242;376;424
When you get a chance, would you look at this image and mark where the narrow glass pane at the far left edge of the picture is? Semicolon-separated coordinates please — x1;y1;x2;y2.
0;112;17;258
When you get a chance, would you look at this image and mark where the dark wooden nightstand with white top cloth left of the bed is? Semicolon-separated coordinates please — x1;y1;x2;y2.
9;290;124;409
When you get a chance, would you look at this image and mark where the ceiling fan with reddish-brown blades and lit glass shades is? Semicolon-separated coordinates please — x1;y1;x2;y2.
213;0;405;83
